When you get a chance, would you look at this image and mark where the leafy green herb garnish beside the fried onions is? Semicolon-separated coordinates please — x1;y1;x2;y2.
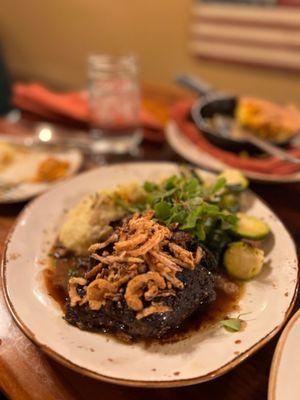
144;170;238;245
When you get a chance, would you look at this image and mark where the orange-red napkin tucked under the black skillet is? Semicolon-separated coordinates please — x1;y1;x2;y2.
171;101;300;175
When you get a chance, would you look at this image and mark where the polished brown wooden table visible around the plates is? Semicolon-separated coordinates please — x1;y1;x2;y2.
0;86;300;400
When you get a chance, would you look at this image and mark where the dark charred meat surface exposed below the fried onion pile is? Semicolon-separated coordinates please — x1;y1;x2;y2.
65;250;216;339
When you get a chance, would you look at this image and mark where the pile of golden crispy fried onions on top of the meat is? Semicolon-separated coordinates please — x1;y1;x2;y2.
69;210;203;319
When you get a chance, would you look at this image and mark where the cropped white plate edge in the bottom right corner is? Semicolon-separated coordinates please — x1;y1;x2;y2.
268;310;300;400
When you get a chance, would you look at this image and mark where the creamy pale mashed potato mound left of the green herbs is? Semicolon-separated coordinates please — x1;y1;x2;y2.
58;183;145;254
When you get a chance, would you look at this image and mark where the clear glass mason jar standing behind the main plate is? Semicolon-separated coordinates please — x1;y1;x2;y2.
88;55;141;153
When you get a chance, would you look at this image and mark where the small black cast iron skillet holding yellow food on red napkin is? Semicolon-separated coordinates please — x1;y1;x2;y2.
176;75;300;164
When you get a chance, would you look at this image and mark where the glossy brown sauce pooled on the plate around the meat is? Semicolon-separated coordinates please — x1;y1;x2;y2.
44;247;243;346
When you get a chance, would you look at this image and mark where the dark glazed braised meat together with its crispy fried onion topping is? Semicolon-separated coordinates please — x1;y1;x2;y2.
65;212;216;338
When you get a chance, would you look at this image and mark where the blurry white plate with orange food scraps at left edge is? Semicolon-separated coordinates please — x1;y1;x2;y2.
0;150;82;204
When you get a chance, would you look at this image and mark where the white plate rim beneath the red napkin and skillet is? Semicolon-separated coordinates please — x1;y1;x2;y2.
165;121;300;183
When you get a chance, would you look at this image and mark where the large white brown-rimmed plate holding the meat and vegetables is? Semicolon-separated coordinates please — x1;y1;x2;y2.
2;163;298;387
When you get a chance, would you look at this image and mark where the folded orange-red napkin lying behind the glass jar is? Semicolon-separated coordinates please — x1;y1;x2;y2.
12;83;164;141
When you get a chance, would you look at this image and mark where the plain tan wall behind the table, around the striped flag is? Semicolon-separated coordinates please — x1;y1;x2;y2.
0;0;300;104
